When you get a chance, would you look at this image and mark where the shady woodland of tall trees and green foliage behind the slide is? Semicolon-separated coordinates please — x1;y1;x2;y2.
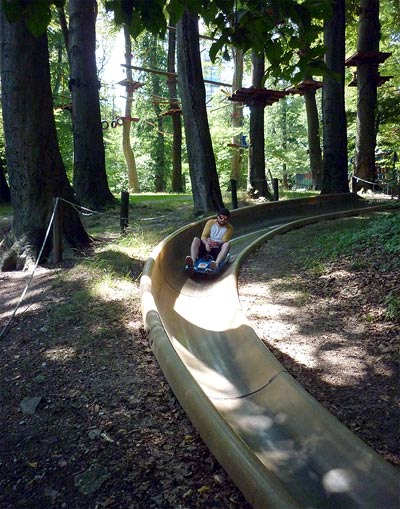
1;0;399;268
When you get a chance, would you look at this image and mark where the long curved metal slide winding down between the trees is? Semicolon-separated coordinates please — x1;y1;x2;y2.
141;194;400;509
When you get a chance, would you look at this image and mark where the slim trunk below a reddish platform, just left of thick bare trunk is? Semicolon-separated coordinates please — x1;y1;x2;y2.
304;90;323;191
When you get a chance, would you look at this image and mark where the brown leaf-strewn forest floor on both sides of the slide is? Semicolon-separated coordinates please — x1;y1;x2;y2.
0;200;400;509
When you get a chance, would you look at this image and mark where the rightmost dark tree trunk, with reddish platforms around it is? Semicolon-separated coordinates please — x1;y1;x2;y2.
355;0;380;188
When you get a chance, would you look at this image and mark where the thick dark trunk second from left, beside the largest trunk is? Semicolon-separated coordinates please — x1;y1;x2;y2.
68;0;115;208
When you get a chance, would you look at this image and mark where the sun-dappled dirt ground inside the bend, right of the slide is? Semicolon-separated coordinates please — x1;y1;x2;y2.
239;223;400;466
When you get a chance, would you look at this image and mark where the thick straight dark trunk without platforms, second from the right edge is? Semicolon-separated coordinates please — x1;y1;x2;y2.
321;0;349;194
